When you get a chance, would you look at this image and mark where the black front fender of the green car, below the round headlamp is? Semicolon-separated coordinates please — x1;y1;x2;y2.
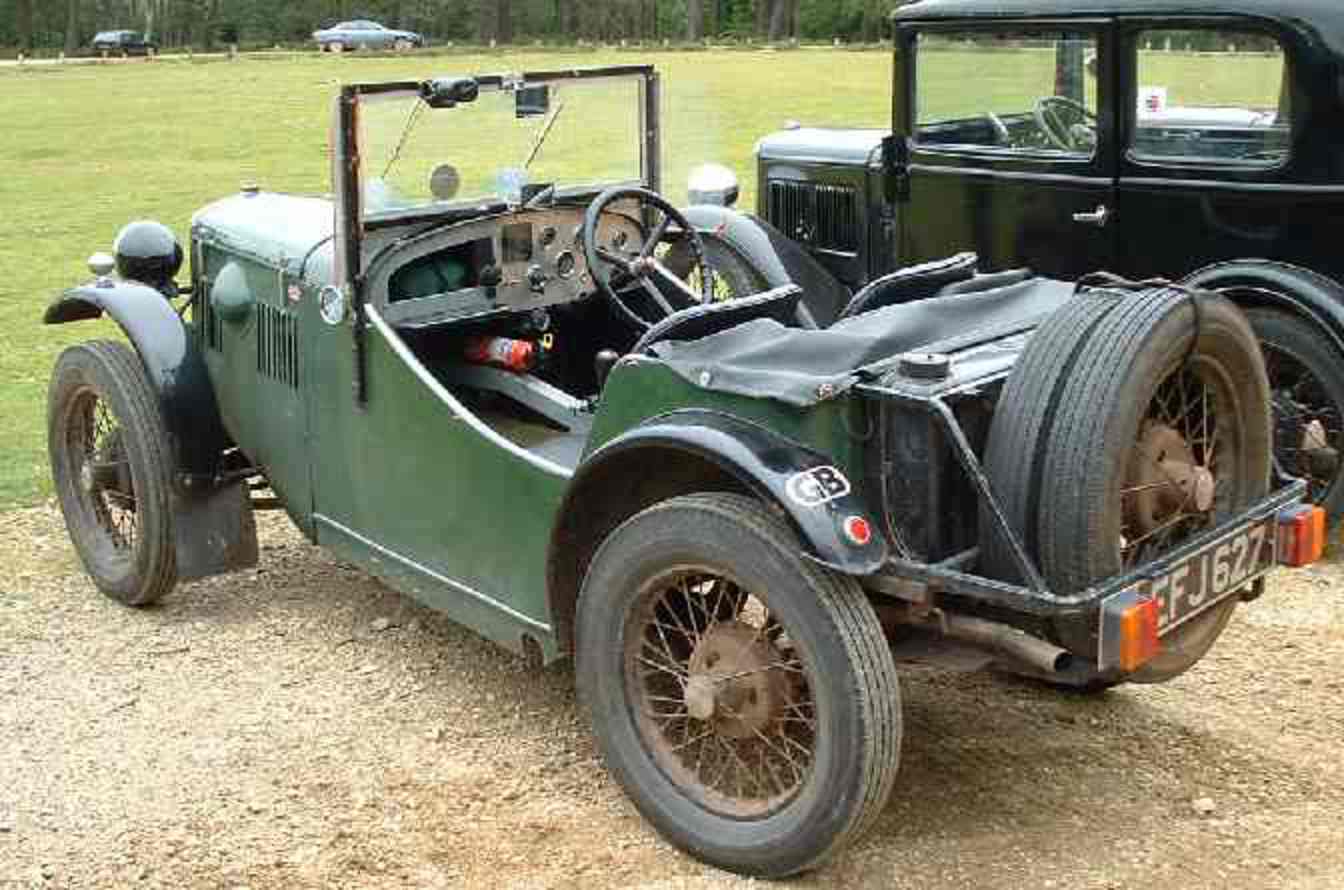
42;281;228;476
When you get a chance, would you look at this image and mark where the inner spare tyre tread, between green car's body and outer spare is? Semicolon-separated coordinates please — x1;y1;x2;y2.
980;290;1124;582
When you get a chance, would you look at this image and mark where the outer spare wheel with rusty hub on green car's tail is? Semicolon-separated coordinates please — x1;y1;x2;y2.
986;289;1271;683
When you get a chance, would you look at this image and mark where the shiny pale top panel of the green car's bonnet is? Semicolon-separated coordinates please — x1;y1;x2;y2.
191;192;335;285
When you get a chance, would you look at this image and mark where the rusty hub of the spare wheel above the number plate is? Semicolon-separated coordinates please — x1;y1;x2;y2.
1126;422;1218;534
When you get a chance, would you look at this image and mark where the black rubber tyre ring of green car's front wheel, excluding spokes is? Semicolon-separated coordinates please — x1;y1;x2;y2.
47;340;177;606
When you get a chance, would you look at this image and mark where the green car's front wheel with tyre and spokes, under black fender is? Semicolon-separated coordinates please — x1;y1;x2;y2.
47;340;177;606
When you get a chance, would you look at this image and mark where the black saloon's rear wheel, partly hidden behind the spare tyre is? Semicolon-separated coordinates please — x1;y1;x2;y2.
1246;309;1344;522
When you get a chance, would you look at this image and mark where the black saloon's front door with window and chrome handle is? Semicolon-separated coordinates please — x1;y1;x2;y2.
895;20;1116;277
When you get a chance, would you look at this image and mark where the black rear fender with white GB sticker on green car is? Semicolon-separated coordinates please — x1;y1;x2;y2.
583;410;887;575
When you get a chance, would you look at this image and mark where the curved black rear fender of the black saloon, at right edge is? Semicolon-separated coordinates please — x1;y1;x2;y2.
1181;259;1344;354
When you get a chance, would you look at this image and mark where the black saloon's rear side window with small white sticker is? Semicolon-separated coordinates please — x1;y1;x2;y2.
1129;28;1292;167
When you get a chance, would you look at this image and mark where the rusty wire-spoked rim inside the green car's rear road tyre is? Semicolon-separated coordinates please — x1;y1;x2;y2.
625;567;817;819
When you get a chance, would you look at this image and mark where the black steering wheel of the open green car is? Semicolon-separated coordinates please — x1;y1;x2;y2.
582;187;714;331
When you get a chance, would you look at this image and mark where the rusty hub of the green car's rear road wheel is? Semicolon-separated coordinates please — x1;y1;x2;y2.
684;621;789;738
